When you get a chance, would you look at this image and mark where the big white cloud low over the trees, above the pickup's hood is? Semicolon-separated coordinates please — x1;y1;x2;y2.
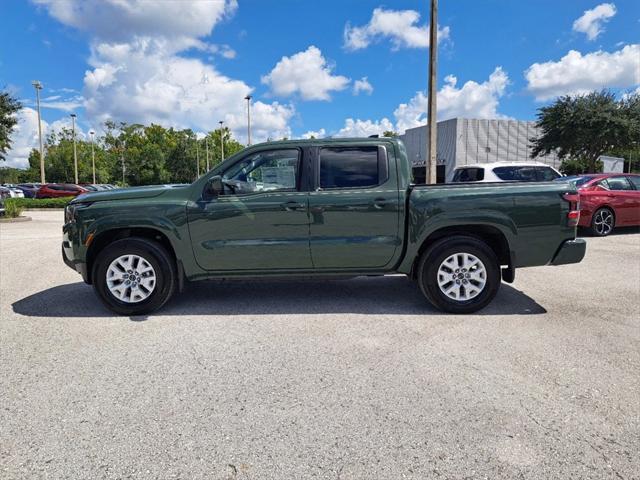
84;39;294;141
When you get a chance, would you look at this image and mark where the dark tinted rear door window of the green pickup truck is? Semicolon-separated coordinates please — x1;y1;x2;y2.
320;147;380;188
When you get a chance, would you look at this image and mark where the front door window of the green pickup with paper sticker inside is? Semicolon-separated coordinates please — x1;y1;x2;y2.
224;148;300;193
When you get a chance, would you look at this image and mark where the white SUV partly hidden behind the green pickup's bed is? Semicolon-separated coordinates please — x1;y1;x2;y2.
449;162;562;183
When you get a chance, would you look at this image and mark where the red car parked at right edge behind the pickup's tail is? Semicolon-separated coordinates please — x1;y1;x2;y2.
557;173;640;237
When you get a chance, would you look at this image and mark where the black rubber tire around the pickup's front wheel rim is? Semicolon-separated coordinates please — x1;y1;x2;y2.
92;237;177;316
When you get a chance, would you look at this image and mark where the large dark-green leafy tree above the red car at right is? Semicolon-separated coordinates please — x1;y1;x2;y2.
531;90;640;173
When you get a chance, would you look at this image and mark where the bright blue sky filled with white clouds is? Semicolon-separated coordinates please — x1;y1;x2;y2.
0;0;640;166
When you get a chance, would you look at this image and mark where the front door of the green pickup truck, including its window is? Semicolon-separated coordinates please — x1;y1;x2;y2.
188;149;312;271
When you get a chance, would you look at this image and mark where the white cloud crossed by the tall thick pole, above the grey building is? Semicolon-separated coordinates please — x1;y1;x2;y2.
393;67;509;132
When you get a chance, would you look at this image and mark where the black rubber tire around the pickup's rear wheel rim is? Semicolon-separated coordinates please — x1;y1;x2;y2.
418;235;501;314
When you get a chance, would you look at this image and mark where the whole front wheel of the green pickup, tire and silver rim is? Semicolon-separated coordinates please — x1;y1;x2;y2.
92;237;177;316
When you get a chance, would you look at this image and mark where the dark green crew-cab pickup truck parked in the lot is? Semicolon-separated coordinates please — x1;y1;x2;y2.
62;138;586;315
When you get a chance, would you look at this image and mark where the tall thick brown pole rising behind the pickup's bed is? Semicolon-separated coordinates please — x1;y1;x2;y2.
425;0;438;184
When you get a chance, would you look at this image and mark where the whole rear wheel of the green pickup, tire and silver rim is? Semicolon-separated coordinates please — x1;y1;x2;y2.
418;235;500;313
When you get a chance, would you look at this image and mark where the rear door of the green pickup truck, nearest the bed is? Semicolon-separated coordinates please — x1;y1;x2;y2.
309;142;401;269
